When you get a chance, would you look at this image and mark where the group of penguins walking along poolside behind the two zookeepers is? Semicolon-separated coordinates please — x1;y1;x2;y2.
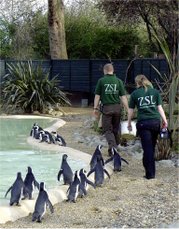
5;123;128;222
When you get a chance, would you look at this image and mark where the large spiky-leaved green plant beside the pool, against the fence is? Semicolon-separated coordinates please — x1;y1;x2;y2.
1;61;70;113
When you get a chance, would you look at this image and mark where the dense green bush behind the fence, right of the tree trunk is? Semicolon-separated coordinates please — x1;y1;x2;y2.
66;12;139;59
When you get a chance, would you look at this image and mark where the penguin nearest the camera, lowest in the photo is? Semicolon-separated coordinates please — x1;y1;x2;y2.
32;182;54;223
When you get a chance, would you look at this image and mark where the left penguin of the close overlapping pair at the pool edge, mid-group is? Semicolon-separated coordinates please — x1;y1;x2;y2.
66;171;80;203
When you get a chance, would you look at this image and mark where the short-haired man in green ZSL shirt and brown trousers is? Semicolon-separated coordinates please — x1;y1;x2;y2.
94;64;128;156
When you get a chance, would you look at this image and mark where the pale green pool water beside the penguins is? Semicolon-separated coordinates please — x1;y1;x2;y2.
0;118;86;203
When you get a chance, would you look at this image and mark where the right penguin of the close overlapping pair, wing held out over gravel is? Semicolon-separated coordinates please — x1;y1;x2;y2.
79;169;96;197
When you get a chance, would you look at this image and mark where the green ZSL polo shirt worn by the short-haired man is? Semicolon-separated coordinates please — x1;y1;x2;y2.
95;75;125;105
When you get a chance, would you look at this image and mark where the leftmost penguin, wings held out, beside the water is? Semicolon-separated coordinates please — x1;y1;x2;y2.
5;172;24;206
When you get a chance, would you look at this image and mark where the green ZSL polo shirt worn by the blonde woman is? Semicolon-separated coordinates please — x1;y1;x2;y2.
129;87;162;121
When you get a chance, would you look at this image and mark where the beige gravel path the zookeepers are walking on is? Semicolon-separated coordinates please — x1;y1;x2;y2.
0;110;179;228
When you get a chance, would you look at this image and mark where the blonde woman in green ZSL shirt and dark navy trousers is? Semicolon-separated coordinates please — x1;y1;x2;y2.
128;75;168;179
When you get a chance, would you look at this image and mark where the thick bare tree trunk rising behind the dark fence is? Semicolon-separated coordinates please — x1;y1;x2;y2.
48;0;68;59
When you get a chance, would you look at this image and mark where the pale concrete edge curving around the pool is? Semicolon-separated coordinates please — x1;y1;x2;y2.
0;115;113;224
